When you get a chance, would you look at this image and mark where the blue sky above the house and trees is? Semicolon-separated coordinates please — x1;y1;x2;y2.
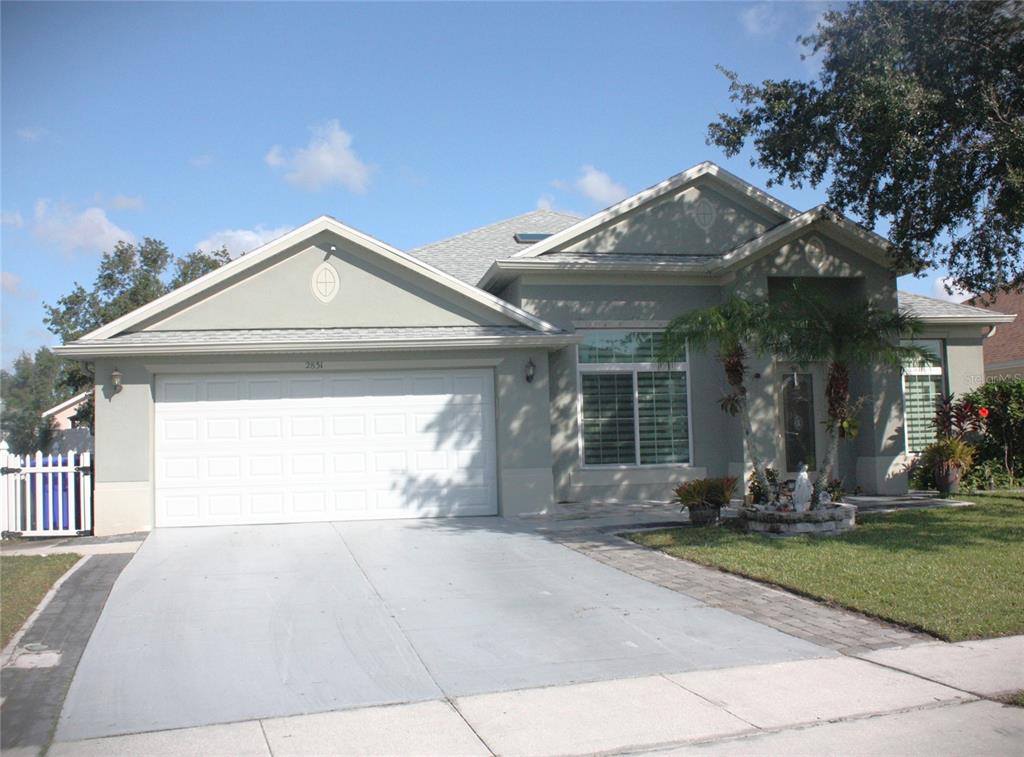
0;2;954;366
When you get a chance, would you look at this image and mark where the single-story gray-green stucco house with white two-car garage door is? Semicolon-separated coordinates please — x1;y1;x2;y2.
58;163;1012;534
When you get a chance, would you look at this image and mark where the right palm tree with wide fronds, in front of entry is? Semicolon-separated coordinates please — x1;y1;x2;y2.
763;282;928;506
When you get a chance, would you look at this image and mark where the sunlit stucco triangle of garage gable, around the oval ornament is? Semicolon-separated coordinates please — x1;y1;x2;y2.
141;234;518;330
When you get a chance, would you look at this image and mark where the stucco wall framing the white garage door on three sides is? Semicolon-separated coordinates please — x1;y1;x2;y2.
95;349;552;535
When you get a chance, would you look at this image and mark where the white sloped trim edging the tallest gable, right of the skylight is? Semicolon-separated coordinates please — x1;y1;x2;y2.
515;161;801;258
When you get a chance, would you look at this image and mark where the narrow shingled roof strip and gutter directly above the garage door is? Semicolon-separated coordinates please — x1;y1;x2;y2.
61;326;579;358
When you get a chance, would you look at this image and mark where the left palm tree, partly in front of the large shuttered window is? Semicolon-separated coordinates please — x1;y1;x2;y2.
657;296;772;503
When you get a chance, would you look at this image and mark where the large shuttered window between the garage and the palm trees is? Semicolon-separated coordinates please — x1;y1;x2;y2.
579;330;690;465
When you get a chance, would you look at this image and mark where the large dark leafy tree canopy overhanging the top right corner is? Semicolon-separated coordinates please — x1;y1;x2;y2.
708;0;1024;292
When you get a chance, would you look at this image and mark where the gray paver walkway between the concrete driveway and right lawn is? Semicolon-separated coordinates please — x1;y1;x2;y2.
549;529;935;655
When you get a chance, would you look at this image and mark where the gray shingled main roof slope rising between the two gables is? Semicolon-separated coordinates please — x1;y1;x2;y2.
410;210;581;284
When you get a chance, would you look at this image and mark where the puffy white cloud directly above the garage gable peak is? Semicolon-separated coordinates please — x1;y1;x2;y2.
263;120;371;194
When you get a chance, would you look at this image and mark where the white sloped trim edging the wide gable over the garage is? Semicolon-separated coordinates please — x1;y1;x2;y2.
64;215;561;354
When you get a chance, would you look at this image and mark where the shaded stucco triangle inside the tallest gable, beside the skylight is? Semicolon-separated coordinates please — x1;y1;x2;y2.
560;179;784;255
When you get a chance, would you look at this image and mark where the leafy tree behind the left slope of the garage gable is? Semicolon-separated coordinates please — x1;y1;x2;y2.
43;237;230;425
